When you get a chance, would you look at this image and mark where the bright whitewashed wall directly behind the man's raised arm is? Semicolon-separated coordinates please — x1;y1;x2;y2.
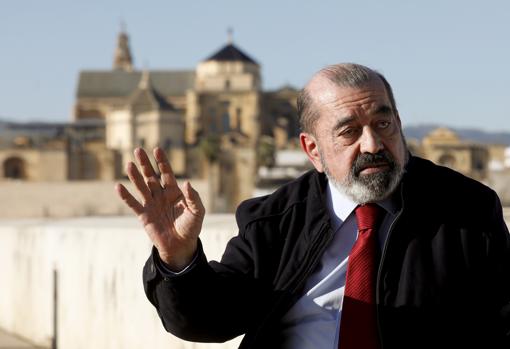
0;215;239;349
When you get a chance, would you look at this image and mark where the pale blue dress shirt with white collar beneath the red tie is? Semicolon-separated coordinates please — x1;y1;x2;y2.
279;182;399;349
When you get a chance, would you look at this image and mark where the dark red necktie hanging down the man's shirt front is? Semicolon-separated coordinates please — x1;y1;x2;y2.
338;204;382;349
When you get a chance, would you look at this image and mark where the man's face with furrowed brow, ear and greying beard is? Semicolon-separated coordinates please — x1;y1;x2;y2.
300;76;407;203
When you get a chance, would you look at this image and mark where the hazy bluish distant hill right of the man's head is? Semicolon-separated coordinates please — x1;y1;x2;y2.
404;124;510;146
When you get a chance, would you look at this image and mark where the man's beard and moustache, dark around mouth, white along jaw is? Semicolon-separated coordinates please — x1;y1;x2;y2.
319;149;404;204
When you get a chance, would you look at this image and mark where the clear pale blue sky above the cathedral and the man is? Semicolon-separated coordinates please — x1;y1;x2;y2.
0;0;510;131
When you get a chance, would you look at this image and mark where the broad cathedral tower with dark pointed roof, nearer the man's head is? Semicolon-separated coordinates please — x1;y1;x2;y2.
186;30;262;144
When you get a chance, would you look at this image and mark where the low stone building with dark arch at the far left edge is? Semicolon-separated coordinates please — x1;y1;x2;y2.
0;120;121;182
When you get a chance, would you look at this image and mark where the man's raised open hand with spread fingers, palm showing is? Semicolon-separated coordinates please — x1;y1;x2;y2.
115;147;205;271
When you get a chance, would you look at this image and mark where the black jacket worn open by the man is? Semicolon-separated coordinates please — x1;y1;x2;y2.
144;157;510;348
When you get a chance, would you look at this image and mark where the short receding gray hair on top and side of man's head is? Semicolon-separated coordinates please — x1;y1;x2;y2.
297;63;397;133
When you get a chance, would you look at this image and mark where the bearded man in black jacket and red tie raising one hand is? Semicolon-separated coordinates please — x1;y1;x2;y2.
117;64;510;349
